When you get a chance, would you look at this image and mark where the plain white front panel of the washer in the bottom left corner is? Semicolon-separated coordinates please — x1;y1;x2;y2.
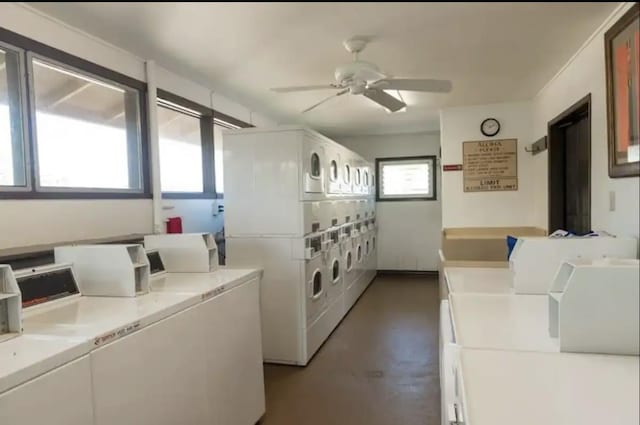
0;356;94;425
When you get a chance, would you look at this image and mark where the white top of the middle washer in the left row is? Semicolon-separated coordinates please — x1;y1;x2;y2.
23;292;200;346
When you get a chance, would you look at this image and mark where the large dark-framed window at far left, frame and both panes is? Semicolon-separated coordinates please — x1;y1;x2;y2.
0;28;151;198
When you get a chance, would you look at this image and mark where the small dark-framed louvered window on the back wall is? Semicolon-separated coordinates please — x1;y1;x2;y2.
376;156;436;201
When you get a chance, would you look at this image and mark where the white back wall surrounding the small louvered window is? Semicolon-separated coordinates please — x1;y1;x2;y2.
336;133;442;270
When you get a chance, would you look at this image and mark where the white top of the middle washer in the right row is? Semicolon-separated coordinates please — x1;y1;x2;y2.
450;294;560;352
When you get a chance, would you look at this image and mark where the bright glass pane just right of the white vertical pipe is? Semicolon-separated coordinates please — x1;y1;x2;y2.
158;106;204;193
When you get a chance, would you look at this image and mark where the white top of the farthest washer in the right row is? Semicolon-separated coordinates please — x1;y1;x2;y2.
444;267;513;294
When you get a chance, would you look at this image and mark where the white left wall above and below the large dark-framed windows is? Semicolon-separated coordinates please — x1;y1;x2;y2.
0;3;272;249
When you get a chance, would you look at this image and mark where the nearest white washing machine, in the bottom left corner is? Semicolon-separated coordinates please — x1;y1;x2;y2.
0;265;93;425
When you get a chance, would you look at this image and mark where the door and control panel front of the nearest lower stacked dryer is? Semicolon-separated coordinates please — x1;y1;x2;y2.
304;233;330;326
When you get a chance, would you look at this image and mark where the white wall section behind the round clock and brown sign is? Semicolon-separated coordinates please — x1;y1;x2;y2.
440;102;540;227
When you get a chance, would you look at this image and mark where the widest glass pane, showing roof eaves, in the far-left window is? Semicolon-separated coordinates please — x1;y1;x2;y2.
32;59;142;189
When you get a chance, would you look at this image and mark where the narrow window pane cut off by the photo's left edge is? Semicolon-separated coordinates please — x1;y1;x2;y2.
0;48;27;186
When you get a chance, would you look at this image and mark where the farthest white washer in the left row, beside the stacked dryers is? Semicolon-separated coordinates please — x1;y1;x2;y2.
147;260;266;425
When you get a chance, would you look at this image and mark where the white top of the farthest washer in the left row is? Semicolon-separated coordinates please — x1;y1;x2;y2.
151;267;262;300
